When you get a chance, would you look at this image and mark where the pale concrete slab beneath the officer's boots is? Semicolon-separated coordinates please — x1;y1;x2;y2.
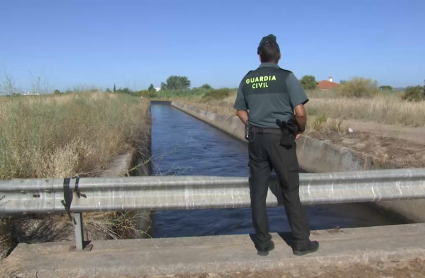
0;224;425;278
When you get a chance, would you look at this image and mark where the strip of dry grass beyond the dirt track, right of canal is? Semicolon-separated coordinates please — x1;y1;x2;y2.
176;91;425;127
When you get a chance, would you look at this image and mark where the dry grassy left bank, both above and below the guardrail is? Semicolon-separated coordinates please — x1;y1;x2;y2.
0;93;150;259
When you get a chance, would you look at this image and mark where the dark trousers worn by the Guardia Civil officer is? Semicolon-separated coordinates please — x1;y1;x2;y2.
248;133;310;250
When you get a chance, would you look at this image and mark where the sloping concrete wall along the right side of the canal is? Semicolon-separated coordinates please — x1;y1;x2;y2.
171;101;425;222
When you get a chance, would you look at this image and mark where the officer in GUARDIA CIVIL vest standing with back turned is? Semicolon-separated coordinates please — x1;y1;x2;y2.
233;35;319;256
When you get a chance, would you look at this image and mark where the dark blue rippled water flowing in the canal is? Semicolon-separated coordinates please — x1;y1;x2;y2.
151;102;401;238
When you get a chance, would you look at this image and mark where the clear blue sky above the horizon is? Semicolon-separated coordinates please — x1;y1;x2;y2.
0;0;425;91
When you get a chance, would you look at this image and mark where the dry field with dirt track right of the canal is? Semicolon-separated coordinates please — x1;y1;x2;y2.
155;89;425;167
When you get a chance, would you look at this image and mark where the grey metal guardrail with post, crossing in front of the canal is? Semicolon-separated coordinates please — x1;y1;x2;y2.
0;169;425;250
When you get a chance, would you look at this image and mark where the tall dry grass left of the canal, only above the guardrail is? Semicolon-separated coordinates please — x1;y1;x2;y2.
0;93;149;180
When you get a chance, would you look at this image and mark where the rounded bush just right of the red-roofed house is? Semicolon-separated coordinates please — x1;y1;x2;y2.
338;77;379;97
